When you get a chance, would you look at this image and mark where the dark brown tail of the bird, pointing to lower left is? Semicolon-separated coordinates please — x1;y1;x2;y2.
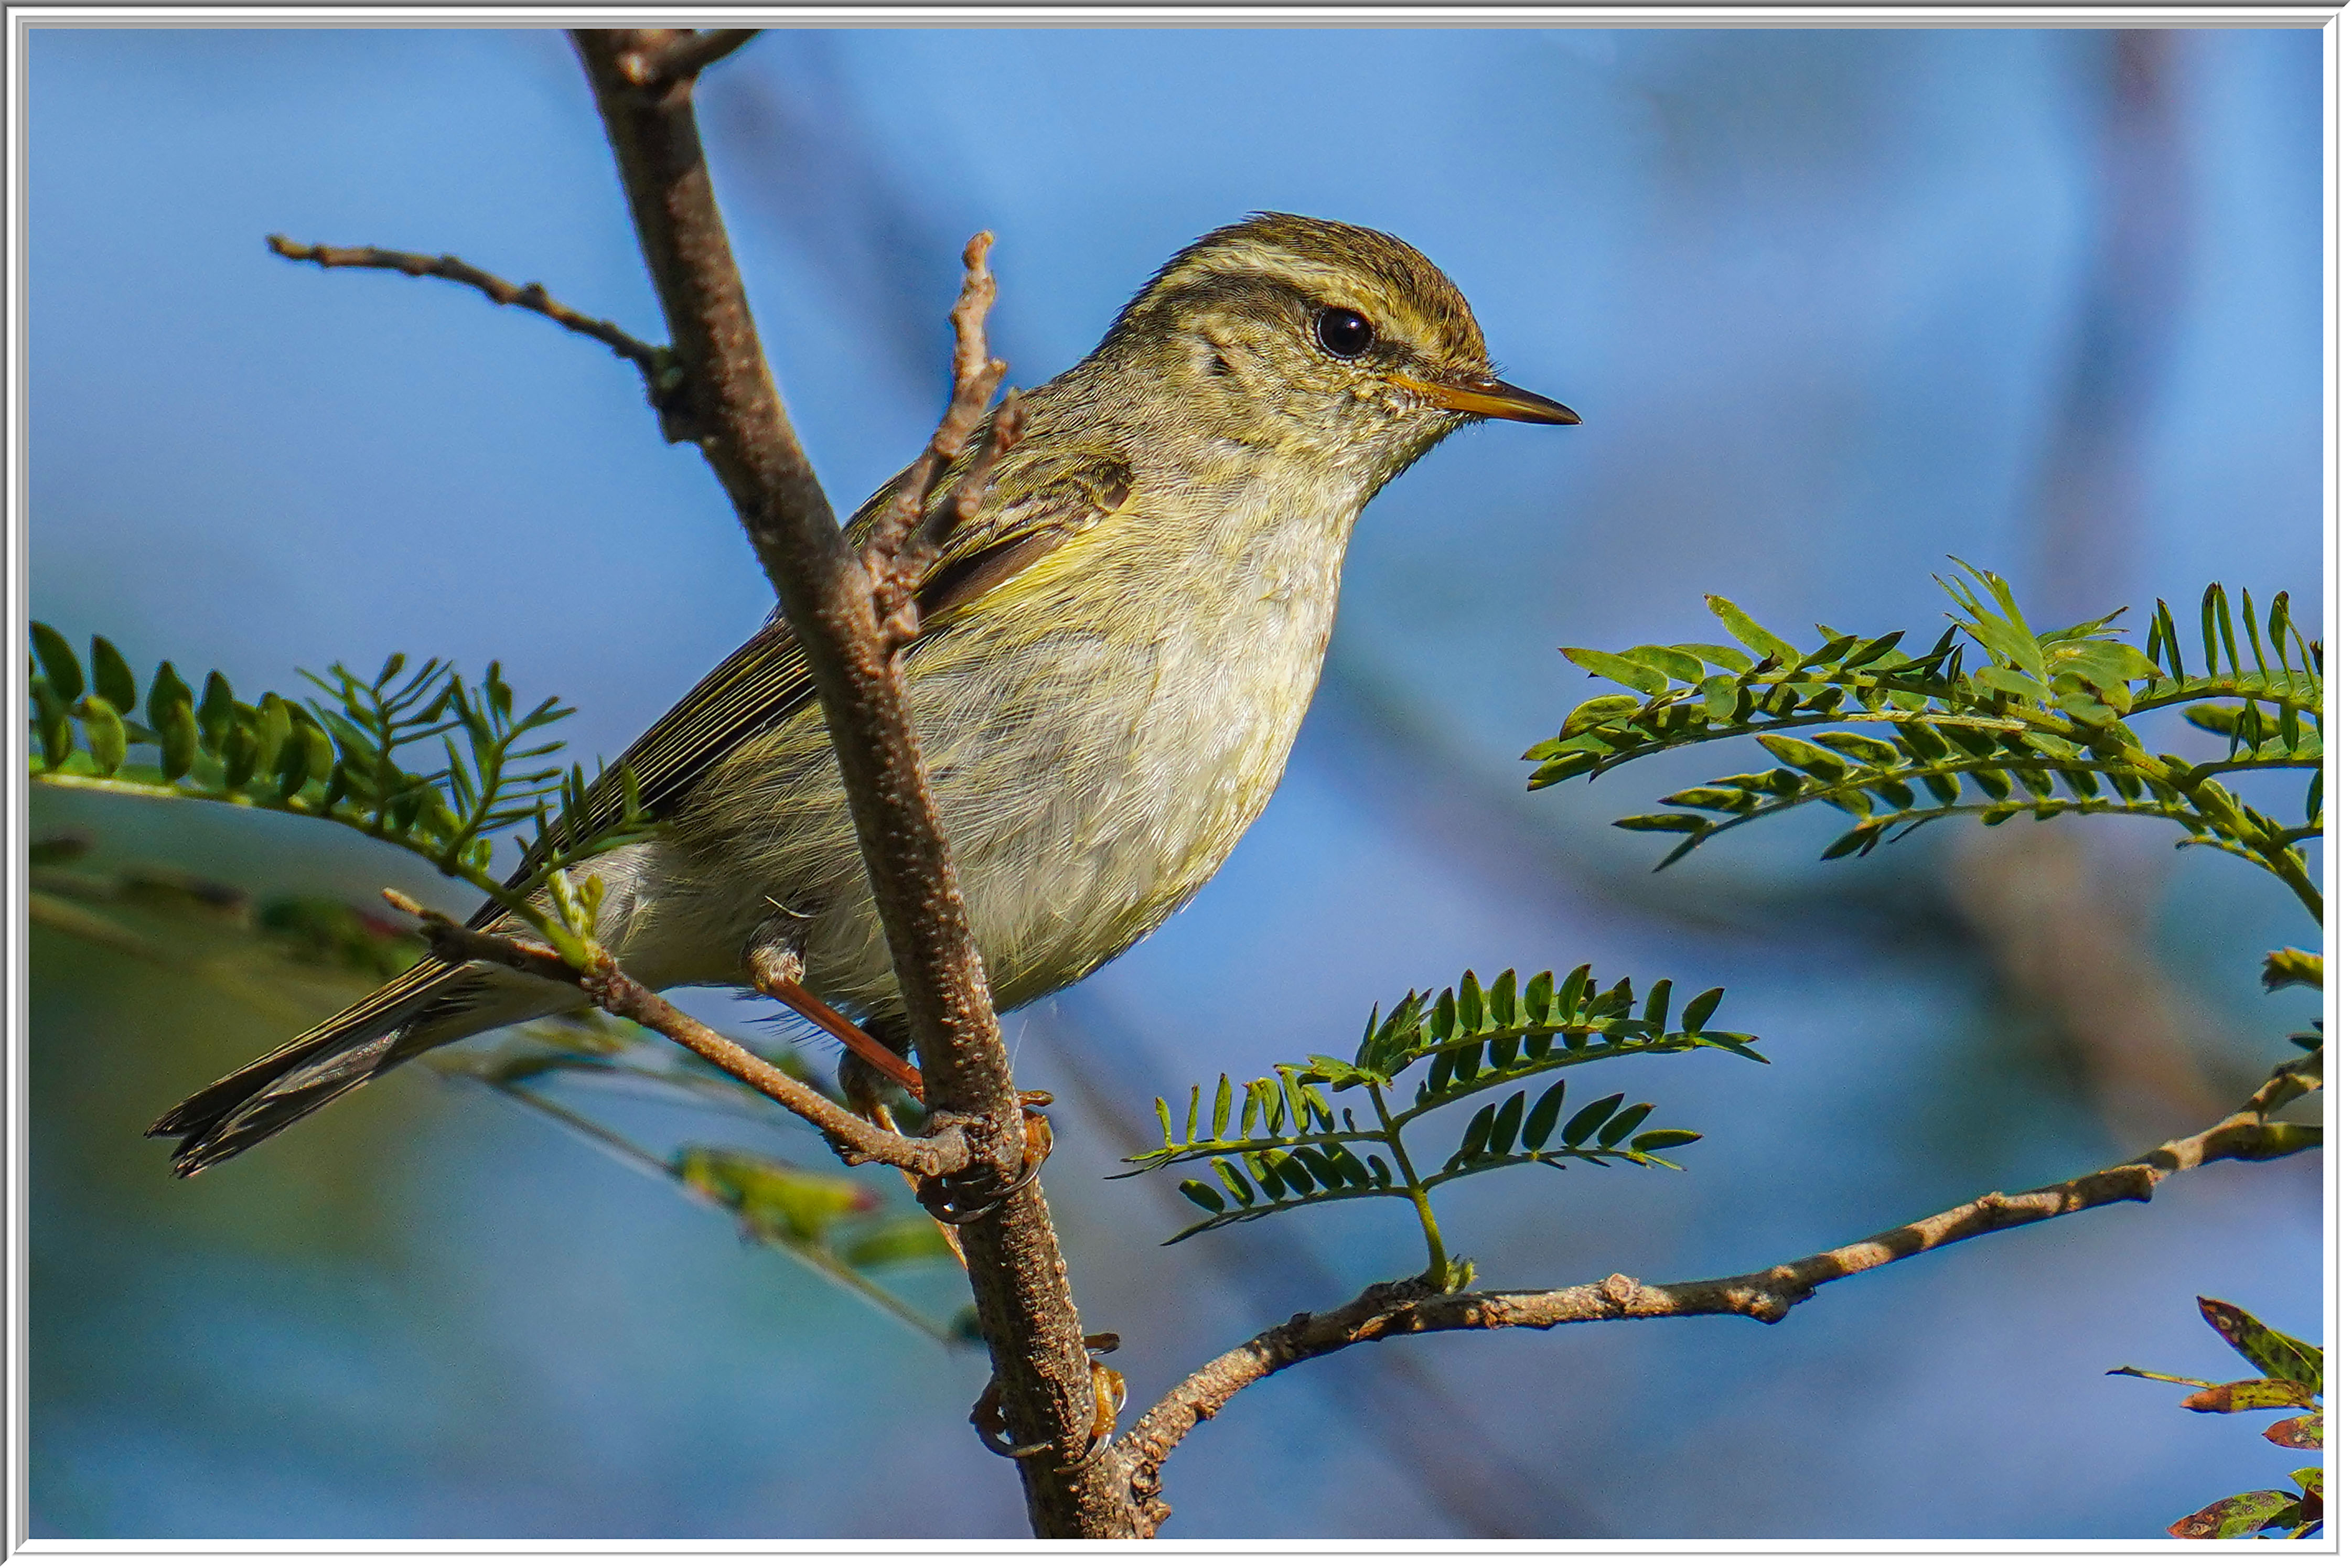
148;959;485;1175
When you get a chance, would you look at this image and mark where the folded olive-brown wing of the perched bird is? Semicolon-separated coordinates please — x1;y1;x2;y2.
472;447;1134;926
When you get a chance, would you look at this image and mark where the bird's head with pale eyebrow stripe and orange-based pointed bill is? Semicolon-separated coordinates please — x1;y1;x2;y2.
1096;211;1578;493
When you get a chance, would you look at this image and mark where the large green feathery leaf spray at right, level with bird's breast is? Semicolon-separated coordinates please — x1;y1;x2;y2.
1527;562;2326;915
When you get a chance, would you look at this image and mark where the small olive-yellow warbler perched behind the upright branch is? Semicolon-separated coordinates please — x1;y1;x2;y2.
151;214;1578;1175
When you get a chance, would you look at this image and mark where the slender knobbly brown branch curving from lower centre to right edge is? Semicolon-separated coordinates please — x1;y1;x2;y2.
1112;1051;2322;1526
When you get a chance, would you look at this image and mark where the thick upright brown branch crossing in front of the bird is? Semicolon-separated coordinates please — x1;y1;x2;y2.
572;30;1139;1535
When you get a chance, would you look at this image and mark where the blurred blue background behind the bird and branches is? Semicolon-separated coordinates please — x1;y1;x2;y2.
30;28;2322;1538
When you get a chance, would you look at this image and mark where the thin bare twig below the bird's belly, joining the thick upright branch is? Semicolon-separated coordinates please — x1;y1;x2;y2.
383;888;974;1175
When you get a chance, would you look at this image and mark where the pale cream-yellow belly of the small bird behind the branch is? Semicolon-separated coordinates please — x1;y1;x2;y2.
644;522;1338;1016
